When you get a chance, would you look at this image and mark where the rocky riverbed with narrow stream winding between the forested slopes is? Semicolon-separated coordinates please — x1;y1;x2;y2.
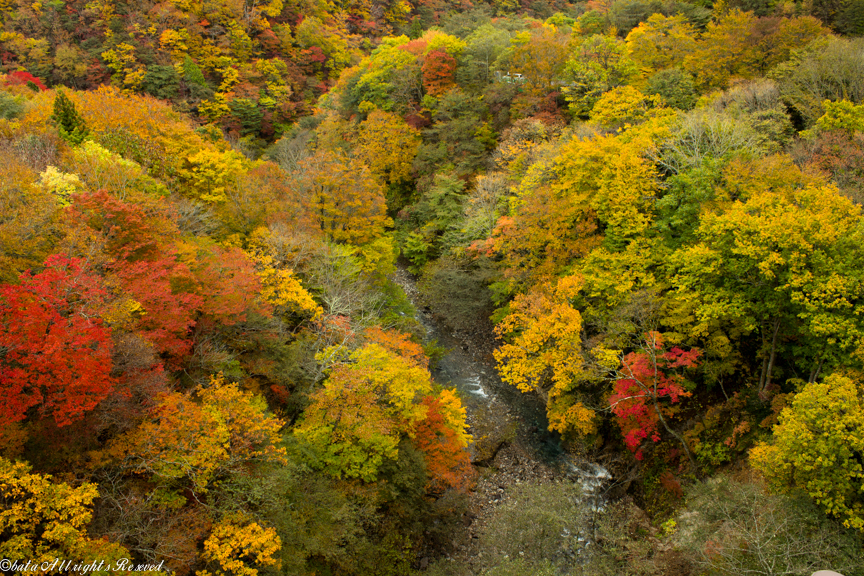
394;268;610;567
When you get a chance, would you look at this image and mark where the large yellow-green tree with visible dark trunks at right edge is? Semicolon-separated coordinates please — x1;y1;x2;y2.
668;179;864;397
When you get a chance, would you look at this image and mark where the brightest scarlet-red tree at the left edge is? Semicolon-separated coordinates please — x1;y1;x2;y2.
0;255;114;426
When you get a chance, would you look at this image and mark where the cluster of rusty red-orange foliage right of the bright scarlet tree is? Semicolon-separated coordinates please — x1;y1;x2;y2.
70;190;268;360
